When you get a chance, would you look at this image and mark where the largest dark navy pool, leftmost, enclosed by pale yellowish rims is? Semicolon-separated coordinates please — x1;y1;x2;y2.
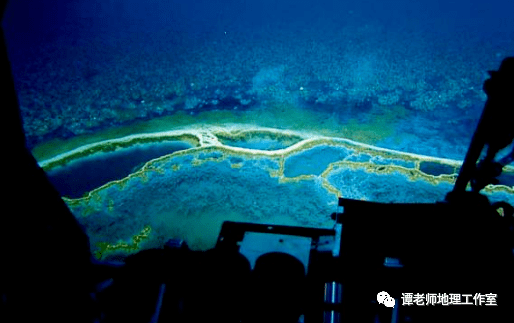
47;142;192;198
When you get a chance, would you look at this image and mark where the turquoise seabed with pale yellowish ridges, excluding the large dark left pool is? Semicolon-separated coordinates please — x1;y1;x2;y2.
40;124;514;258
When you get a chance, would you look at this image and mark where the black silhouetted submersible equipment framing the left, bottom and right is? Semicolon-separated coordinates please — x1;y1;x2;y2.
0;2;514;323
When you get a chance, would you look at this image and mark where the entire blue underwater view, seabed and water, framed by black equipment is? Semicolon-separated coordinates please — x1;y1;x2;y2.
4;0;514;257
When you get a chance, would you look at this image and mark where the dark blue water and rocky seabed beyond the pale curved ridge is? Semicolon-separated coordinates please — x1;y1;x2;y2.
3;0;514;159
